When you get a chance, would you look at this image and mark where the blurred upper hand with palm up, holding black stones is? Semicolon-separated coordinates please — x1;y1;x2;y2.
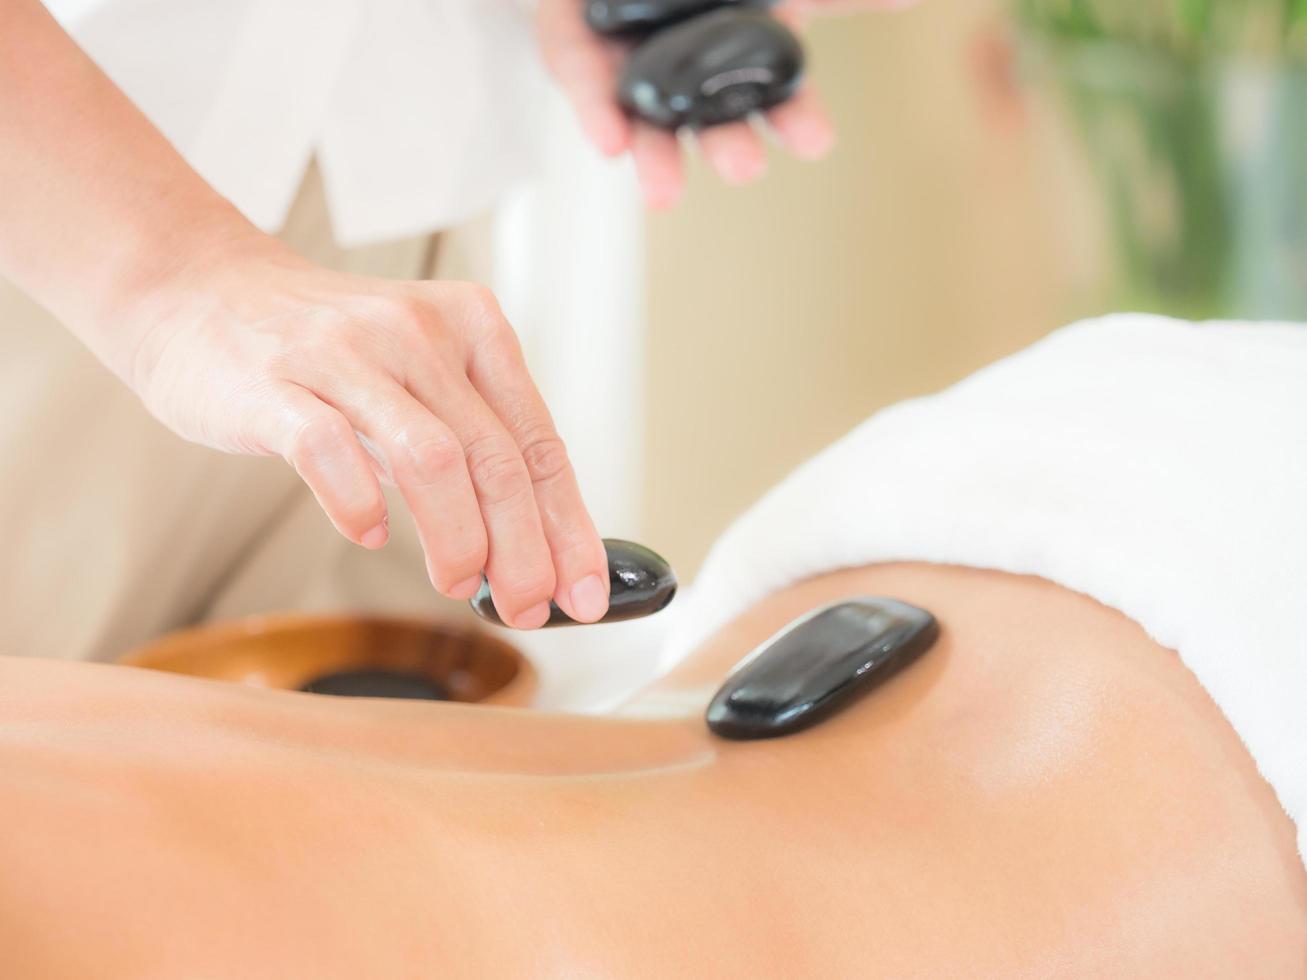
538;0;911;209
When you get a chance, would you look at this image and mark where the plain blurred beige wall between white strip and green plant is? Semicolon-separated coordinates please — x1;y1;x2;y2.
643;0;1094;578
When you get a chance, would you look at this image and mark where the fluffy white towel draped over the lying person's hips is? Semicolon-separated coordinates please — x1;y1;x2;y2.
661;315;1307;855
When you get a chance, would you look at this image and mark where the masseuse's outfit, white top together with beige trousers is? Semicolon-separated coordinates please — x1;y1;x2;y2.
0;0;546;660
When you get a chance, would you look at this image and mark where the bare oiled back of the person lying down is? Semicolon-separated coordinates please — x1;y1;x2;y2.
0;566;1307;977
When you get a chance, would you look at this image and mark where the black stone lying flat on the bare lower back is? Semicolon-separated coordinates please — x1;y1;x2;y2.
707;597;940;738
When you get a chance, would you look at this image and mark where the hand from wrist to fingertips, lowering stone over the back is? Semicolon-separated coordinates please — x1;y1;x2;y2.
125;246;608;629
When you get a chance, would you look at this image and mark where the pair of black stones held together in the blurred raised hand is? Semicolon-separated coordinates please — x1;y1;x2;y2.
586;0;804;129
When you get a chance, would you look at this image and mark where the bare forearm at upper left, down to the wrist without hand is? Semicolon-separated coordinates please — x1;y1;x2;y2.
0;0;273;376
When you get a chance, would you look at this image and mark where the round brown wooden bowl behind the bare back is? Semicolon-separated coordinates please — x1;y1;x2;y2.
119;615;536;706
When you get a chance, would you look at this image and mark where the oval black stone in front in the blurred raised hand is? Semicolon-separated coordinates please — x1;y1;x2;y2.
618;9;804;129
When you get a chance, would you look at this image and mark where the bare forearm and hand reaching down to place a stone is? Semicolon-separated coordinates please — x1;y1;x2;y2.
0;0;608;629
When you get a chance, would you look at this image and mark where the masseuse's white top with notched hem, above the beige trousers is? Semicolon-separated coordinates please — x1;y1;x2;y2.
47;0;545;246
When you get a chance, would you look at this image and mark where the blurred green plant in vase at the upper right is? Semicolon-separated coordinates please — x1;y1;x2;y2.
1014;0;1307;320
